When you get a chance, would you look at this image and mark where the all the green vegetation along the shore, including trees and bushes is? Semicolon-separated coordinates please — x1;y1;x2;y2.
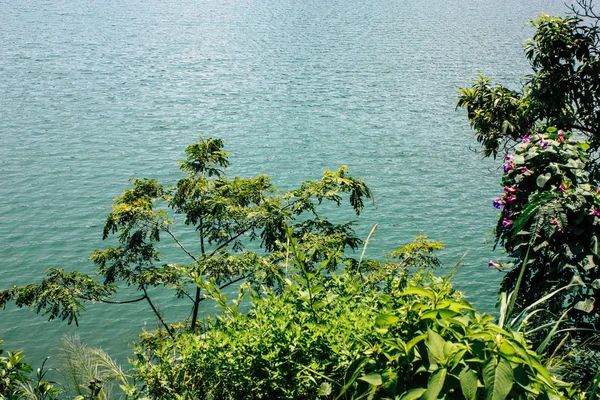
0;0;600;400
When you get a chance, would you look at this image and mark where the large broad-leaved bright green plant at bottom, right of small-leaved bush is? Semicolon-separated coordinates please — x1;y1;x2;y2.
345;280;572;399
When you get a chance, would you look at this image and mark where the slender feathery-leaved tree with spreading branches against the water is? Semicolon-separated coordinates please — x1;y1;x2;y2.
0;138;372;335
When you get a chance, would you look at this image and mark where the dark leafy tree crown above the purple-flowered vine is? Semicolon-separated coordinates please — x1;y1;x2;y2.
458;10;600;157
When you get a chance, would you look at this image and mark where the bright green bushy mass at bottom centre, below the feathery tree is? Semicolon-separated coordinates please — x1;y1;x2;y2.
134;238;562;399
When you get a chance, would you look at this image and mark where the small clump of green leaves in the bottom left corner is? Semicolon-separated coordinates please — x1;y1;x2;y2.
0;340;61;400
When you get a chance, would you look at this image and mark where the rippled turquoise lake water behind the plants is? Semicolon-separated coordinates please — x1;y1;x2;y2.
0;0;566;363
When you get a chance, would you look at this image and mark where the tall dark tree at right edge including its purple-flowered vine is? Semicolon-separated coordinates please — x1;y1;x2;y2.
458;0;600;378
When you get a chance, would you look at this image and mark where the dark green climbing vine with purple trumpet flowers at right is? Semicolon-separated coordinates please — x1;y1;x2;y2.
491;128;600;340
